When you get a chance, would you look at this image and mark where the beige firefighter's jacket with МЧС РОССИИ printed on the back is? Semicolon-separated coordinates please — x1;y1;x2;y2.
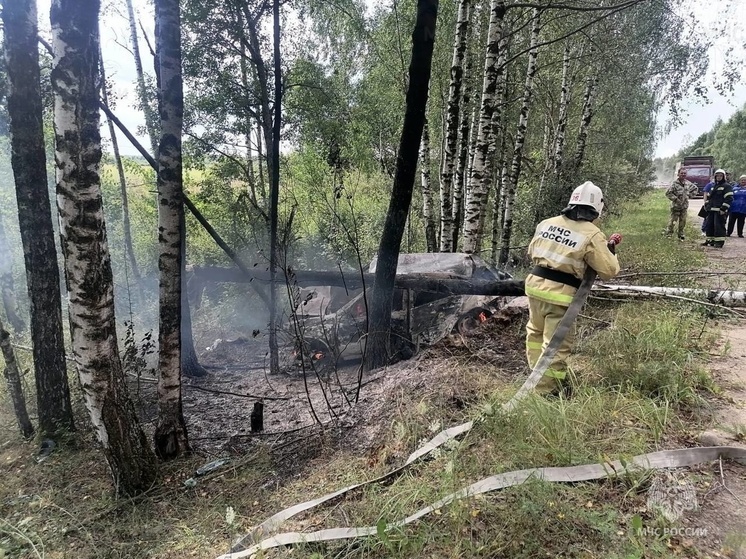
525;215;619;307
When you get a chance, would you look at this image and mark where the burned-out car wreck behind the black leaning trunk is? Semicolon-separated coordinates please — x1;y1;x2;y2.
285;253;512;367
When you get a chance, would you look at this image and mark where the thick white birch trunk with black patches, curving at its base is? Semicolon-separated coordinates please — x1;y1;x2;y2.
50;0;156;496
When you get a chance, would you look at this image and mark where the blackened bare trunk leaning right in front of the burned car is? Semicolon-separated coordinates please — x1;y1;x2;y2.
364;0;438;370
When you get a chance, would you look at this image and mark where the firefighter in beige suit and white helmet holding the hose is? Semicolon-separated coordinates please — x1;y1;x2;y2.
525;181;622;394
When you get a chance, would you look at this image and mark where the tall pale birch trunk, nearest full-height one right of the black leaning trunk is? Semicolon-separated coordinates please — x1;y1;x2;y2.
440;0;471;252
